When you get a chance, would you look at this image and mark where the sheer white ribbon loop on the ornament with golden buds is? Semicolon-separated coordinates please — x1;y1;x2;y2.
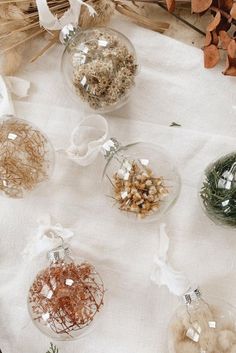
66;114;109;166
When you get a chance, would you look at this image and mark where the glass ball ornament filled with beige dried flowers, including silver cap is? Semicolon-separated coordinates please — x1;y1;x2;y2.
60;24;138;112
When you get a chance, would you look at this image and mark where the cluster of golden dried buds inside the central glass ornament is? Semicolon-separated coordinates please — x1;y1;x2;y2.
111;161;168;218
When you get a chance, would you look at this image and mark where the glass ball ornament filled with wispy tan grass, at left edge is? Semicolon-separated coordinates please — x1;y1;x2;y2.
0;116;55;198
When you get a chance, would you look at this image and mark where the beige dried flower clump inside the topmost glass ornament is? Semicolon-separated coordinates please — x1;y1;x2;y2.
70;29;137;110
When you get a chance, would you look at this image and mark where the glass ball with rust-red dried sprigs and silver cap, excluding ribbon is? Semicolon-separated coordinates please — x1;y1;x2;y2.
28;245;104;341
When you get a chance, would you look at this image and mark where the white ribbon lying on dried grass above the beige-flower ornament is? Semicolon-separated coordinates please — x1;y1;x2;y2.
36;0;96;31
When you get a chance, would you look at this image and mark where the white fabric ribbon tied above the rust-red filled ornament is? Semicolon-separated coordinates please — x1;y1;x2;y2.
22;216;74;260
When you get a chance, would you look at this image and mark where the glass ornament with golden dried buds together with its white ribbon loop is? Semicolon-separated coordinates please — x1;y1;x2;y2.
67;115;180;222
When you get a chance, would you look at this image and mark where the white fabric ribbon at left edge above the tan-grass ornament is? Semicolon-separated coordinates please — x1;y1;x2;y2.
0;75;30;117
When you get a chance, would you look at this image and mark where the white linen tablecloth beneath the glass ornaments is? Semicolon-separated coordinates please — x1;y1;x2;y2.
0;15;236;353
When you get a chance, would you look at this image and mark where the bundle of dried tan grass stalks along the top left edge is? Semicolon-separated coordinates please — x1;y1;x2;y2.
0;0;169;75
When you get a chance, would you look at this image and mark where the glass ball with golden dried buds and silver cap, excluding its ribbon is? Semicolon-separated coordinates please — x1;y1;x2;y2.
102;138;180;222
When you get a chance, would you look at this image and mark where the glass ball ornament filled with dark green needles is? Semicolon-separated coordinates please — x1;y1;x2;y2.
199;152;236;227
